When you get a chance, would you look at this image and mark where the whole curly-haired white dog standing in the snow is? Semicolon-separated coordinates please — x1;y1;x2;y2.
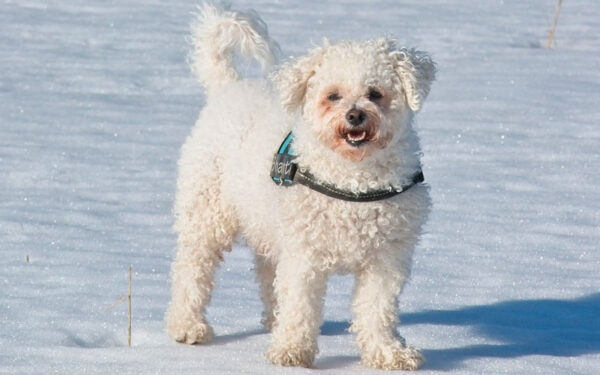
166;5;435;370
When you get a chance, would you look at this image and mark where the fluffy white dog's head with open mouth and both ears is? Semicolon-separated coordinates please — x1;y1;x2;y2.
275;38;435;161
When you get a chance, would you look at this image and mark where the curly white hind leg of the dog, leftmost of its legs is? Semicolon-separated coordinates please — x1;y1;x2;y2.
166;157;237;344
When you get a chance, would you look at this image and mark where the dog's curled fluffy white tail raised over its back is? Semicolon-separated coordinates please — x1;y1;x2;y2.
190;2;279;90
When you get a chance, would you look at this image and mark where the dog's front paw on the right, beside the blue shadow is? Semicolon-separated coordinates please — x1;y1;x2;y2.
361;347;425;371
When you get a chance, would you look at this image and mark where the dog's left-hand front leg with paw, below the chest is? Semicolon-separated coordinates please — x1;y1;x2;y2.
267;252;327;367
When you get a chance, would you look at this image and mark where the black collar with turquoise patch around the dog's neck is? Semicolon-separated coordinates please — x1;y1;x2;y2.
271;132;425;202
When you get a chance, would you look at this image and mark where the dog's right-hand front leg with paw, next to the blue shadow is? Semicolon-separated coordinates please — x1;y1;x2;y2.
351;259;424;370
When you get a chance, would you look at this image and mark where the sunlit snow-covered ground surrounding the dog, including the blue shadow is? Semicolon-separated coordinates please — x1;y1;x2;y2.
0;0;600;375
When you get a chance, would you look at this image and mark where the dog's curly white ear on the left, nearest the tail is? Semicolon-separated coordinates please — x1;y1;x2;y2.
273;47;324;112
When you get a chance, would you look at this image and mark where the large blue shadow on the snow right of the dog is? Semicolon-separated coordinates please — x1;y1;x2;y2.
401;293;600;370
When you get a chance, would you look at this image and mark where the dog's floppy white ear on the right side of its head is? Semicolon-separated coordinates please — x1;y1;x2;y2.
390;48;436;112
